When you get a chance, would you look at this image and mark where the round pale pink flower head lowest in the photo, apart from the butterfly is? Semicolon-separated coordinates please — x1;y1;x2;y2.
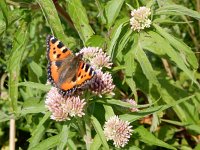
104;116;133;148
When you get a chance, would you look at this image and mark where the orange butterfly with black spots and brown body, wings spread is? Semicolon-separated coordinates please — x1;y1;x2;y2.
46;35;96;96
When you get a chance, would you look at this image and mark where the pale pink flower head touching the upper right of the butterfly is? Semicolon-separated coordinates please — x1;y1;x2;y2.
78;47;112;69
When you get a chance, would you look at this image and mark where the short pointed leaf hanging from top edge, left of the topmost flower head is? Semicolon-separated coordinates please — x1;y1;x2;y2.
105;0;124;28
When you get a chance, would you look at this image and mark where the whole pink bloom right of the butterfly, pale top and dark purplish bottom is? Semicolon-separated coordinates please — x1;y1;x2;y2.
78;47;115;96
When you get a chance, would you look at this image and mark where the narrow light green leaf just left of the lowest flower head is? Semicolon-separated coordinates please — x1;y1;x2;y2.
91;116;109;150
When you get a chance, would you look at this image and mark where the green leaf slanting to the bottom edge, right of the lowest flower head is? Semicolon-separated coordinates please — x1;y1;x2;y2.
134;126;176;149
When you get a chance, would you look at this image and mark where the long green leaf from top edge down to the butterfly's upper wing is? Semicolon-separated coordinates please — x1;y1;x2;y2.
36;0;75;48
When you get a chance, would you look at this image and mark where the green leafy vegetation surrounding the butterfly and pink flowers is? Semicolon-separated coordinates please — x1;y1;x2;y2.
0;0;200;149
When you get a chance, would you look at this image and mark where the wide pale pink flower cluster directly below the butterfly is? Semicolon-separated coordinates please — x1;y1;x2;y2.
45;87;86;121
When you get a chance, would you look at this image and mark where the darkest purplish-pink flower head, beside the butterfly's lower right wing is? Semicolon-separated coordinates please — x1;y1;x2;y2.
90;70;115;96
